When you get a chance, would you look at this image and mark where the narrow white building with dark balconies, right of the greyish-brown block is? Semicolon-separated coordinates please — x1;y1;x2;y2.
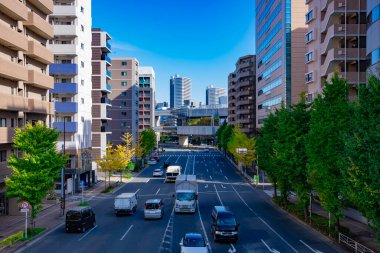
138;67;156;131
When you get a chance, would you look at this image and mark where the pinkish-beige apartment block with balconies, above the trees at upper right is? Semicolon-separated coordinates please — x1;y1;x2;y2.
304;0;368;102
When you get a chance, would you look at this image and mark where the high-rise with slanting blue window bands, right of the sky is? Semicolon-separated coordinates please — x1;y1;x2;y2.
256;0;308;128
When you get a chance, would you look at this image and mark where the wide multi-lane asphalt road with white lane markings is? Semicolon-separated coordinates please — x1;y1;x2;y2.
18;151;343;253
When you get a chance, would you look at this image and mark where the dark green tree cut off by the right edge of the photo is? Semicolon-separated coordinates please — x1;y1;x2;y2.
346;76;380;241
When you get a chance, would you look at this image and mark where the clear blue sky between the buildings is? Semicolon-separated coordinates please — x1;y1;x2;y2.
92;0;255;104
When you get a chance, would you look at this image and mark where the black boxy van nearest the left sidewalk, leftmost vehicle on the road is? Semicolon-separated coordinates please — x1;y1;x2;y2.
65;206;96;233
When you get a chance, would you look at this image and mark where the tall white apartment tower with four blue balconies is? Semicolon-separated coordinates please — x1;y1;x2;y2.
49;0;95;192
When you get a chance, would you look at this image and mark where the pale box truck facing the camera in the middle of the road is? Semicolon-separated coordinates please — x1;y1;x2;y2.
174;175;198;213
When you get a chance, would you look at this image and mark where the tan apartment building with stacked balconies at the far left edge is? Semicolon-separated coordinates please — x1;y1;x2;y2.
0;0;54;216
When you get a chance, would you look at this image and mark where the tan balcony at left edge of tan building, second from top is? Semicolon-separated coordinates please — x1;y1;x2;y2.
0;22;28;51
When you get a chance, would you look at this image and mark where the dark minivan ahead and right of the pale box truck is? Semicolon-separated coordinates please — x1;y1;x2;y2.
211;206;239;242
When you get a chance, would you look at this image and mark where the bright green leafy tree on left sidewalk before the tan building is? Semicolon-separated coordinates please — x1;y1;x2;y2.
5;123;67;225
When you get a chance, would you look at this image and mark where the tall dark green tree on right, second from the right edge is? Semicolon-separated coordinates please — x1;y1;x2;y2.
306;75;353;230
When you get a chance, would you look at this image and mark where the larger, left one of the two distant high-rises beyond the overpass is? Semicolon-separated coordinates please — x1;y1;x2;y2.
170;75;191;108
